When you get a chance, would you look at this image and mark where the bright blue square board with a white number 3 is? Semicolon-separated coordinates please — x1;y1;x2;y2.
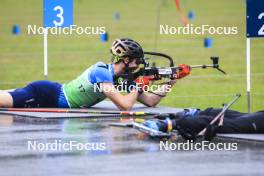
43;0;73;27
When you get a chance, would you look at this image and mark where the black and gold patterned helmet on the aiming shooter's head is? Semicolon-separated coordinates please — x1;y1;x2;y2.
110;38;144;64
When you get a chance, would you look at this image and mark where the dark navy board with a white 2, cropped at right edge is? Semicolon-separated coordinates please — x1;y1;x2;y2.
247;0;264;37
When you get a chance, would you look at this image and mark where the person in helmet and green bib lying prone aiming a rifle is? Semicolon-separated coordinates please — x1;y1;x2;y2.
0;38;190;110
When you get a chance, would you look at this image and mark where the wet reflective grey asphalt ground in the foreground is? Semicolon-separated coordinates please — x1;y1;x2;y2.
0;115;264;176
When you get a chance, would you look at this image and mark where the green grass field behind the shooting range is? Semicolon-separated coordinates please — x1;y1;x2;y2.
0;0;264;111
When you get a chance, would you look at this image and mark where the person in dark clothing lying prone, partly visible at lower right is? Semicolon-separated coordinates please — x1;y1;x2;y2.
144;108;264;140
